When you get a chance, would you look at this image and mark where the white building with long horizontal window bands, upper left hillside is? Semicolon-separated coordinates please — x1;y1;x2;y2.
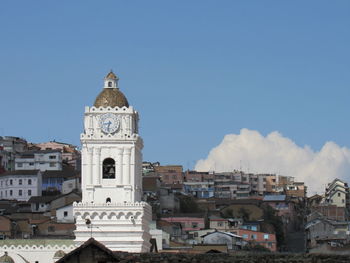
15;150;62;171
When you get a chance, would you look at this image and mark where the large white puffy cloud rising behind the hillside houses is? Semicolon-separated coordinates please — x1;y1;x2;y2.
195;129;350;195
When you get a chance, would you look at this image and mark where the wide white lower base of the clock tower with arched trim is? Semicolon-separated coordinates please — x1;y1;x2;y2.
73;202;152;253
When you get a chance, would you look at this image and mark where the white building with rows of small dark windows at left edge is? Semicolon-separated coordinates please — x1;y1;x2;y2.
0;170;42;201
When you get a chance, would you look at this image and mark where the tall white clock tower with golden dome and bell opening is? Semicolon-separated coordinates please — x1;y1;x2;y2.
74;71;151;252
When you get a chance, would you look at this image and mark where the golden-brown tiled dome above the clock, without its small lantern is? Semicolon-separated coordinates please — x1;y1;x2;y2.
94;88;129;108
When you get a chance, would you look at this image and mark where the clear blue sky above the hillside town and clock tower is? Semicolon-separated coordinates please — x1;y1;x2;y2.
0;0;350;168
